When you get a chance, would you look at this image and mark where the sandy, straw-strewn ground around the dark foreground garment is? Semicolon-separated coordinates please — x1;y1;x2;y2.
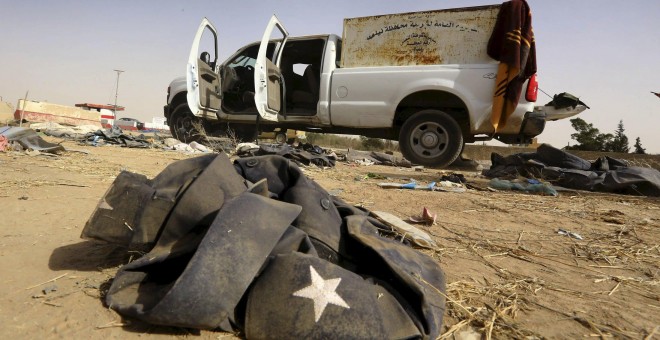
0;142;660;339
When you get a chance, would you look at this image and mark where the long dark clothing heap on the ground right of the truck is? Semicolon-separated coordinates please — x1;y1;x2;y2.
483;144;660;196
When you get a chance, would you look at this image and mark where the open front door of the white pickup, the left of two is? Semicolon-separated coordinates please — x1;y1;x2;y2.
186;18;222;115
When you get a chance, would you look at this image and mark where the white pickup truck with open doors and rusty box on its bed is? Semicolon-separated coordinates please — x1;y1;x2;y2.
164;5;584;166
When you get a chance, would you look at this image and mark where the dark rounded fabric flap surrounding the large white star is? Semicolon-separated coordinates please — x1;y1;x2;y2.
245;253;421;339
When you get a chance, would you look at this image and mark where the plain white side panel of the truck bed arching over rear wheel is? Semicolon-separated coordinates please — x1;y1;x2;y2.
330;64;534;134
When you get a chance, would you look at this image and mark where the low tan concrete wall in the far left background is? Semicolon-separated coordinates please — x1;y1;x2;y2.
14;99;101;127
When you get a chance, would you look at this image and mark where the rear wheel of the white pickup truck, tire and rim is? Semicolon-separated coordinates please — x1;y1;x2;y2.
399;109;464;167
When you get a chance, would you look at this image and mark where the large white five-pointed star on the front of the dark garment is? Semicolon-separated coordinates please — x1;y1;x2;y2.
293;265;351;322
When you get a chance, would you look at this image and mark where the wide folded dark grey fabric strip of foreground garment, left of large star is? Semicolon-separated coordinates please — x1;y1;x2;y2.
107;193;300;331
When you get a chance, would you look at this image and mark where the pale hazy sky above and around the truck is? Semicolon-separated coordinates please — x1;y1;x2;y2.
0;0;660;154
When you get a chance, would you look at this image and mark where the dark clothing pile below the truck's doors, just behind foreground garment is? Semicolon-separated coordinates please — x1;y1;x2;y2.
236;143;336;167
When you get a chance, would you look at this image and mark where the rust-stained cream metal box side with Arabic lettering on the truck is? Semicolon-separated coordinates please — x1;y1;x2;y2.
341;5;500;67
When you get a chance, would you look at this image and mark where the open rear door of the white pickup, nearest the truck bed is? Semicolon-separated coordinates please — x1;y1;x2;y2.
254;15;289;121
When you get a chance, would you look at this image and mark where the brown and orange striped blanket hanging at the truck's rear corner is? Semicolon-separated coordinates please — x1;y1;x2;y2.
487;0;536;132
